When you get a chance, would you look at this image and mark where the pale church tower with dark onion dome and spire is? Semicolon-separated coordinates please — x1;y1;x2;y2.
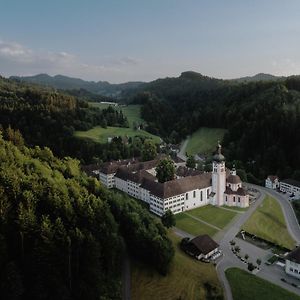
212;143;226;206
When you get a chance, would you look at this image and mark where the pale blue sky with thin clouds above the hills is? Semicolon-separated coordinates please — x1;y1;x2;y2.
0;0;300;83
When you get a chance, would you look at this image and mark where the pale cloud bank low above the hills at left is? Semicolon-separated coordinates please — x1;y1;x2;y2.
0;40;140;81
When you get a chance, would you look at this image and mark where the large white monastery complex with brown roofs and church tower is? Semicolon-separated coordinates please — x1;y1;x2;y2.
99;145;249;216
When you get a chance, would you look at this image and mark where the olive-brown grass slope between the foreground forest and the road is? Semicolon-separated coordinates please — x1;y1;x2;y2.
131;233;223;300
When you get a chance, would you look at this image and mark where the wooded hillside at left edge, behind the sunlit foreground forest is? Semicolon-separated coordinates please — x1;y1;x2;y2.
0;78;129;163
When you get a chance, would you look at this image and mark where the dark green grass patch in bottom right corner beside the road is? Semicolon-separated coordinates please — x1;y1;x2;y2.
225;268;300;300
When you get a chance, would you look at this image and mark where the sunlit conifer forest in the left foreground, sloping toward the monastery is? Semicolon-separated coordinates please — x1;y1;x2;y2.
0;137;174;300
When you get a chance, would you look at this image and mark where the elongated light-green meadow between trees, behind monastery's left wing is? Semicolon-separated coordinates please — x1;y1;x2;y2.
74;126;160;143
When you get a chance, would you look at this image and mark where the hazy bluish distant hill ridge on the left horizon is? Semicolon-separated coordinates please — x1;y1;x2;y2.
10;74;143;98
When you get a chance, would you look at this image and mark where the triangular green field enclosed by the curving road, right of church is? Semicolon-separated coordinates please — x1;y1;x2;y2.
242;196;295;249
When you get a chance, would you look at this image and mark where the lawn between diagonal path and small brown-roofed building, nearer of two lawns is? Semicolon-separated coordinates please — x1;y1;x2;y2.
175;213;218;237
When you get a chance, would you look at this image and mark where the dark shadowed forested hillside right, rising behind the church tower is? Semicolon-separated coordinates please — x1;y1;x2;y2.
134;72;300;181
